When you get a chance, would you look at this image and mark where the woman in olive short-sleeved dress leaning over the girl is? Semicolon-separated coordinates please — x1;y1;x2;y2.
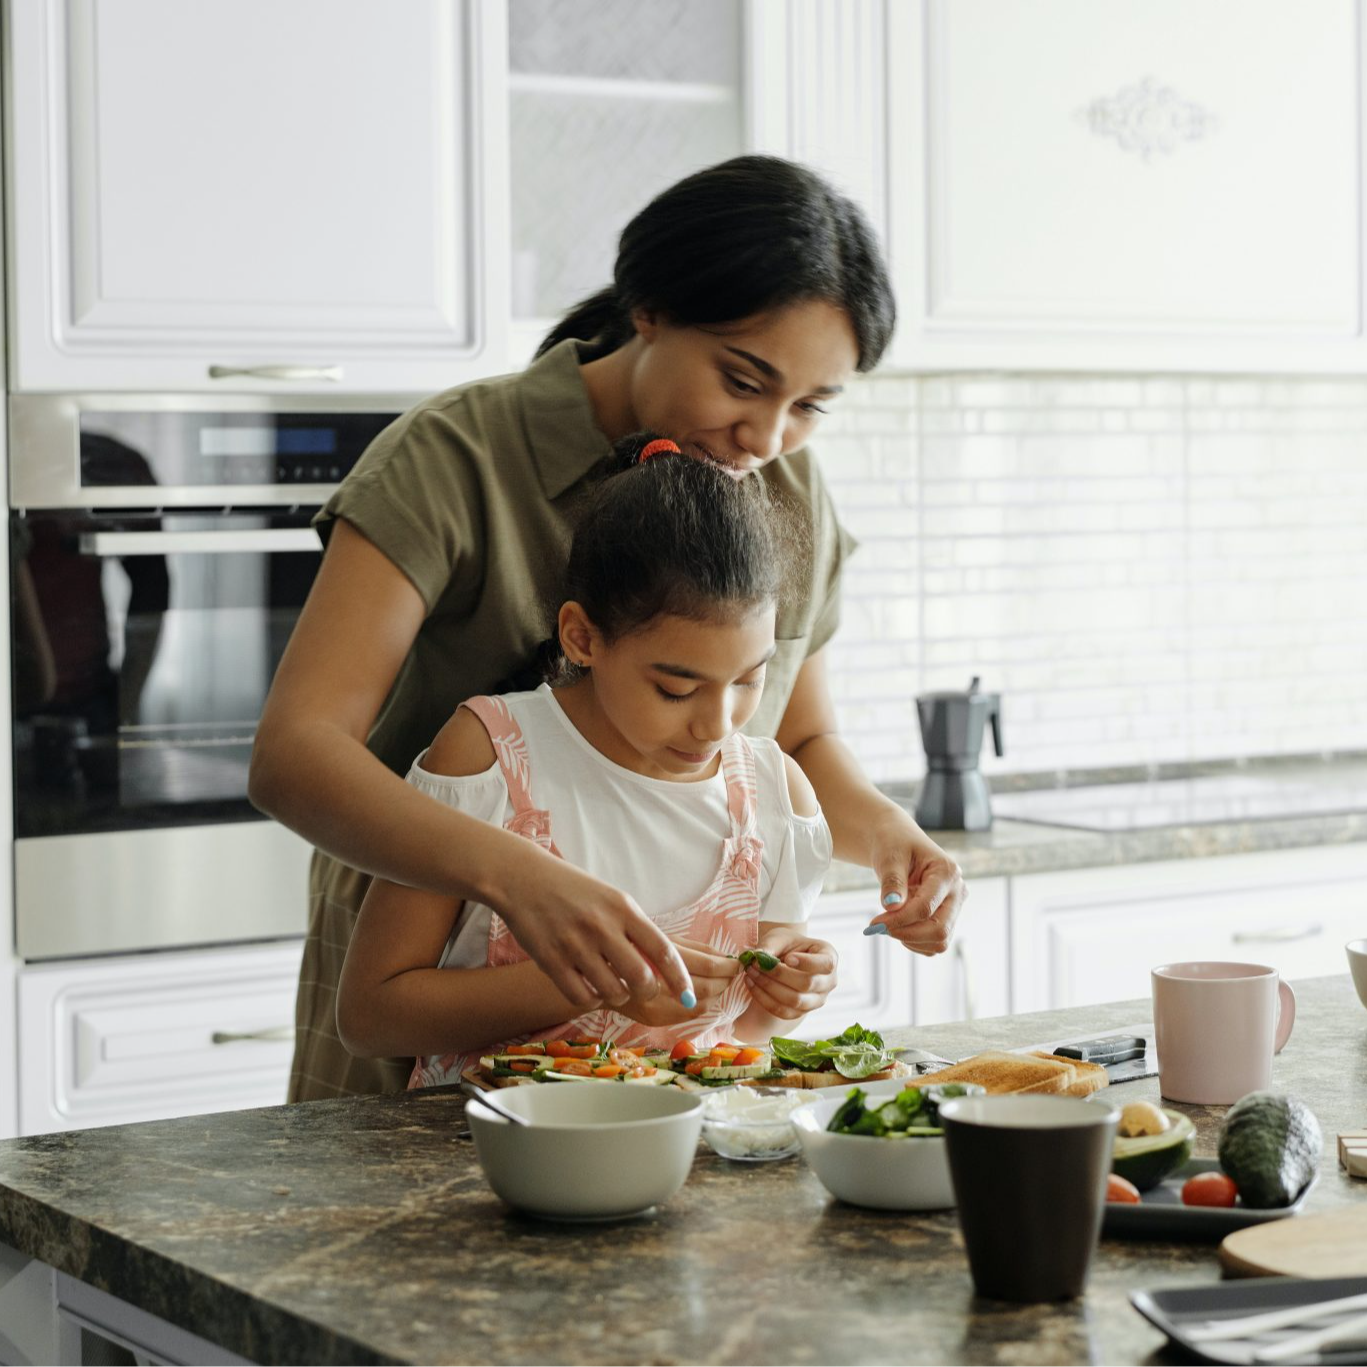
250;156;964;1100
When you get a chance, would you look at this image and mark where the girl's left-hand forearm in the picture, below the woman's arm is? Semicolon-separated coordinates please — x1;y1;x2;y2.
338;961;578;1058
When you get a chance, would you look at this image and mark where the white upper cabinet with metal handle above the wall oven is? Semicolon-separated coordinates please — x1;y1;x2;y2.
7;0;507;392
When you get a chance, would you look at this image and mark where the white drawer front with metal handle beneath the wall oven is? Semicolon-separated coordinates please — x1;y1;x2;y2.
19;940;302;1135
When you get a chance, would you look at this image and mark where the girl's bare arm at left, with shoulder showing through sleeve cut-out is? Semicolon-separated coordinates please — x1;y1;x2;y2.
338;708;590;1058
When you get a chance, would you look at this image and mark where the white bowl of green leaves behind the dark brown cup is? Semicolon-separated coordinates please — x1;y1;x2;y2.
793;1079;954;1210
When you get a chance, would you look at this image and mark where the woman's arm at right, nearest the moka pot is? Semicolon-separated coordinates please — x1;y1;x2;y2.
778;651;968;954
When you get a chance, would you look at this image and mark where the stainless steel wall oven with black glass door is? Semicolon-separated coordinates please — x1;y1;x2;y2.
10;395;403;960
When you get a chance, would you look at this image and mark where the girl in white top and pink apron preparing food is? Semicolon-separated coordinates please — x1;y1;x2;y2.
338;437;835;1085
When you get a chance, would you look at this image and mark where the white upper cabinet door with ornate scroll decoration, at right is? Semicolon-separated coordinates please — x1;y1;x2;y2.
886;0;1367;370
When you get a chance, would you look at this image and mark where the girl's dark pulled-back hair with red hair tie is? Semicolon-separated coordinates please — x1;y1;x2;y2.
524;432;805;686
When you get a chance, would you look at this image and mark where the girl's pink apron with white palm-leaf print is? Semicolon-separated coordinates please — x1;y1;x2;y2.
409;697;764;1088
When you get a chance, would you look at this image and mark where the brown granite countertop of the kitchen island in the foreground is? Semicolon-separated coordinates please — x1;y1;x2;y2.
0;976;1367;1367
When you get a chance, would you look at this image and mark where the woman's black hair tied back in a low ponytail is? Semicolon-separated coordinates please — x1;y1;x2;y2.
537;156;895;370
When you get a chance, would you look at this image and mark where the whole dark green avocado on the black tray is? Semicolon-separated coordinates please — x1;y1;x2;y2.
1217;1092;1325;1210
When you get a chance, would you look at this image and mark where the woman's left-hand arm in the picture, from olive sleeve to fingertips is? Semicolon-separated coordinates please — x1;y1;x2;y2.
249;521;689;1010
